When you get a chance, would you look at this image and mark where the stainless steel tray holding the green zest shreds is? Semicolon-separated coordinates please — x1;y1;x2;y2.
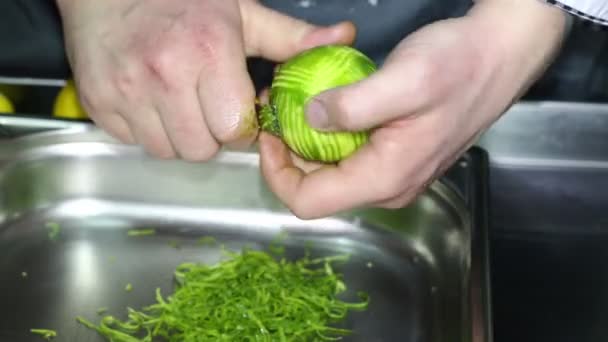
0;127;491;342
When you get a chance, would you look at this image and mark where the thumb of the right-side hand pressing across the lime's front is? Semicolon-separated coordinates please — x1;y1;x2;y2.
306;48;440;131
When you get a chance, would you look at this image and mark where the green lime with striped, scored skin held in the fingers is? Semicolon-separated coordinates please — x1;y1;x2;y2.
269;45;376;163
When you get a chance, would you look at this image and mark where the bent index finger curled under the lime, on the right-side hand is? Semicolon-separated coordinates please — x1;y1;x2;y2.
260;133;397;219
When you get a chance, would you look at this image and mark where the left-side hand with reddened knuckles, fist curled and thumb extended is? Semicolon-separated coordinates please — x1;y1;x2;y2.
57;0;355;161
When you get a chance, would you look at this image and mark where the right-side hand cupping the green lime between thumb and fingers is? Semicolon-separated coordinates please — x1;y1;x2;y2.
260;0;566;219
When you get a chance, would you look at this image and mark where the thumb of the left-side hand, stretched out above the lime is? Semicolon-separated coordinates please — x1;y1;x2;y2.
241;1;356;61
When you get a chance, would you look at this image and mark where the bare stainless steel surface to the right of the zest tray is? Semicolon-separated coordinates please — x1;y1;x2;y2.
479;102;608;342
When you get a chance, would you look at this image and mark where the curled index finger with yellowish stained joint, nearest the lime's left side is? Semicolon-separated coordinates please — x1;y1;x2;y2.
197;23;258;148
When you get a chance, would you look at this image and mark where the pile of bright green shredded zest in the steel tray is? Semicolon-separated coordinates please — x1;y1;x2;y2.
77;244;369;342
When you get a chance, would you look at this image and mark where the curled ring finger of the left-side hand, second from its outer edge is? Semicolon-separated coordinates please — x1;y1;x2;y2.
123;107;175;159
